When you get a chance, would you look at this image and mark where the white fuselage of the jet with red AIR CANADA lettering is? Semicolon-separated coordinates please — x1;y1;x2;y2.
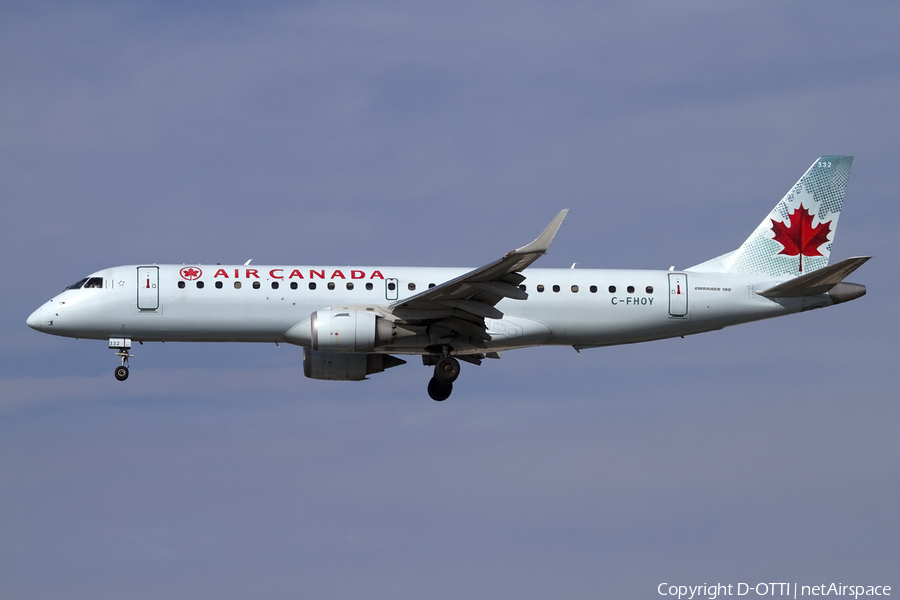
28;265;832;354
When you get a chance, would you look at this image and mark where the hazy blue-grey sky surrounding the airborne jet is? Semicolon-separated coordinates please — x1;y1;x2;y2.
0;1;900;600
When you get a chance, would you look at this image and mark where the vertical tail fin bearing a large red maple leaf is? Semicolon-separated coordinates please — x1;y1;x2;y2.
689;156;853;275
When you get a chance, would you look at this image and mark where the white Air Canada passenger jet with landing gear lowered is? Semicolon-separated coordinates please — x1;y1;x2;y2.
27;156;871;401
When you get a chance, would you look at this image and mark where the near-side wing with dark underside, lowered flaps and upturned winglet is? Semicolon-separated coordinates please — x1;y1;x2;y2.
390;209;569;348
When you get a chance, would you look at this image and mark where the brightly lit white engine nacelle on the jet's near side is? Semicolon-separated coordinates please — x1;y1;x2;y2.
309;308;393;352
